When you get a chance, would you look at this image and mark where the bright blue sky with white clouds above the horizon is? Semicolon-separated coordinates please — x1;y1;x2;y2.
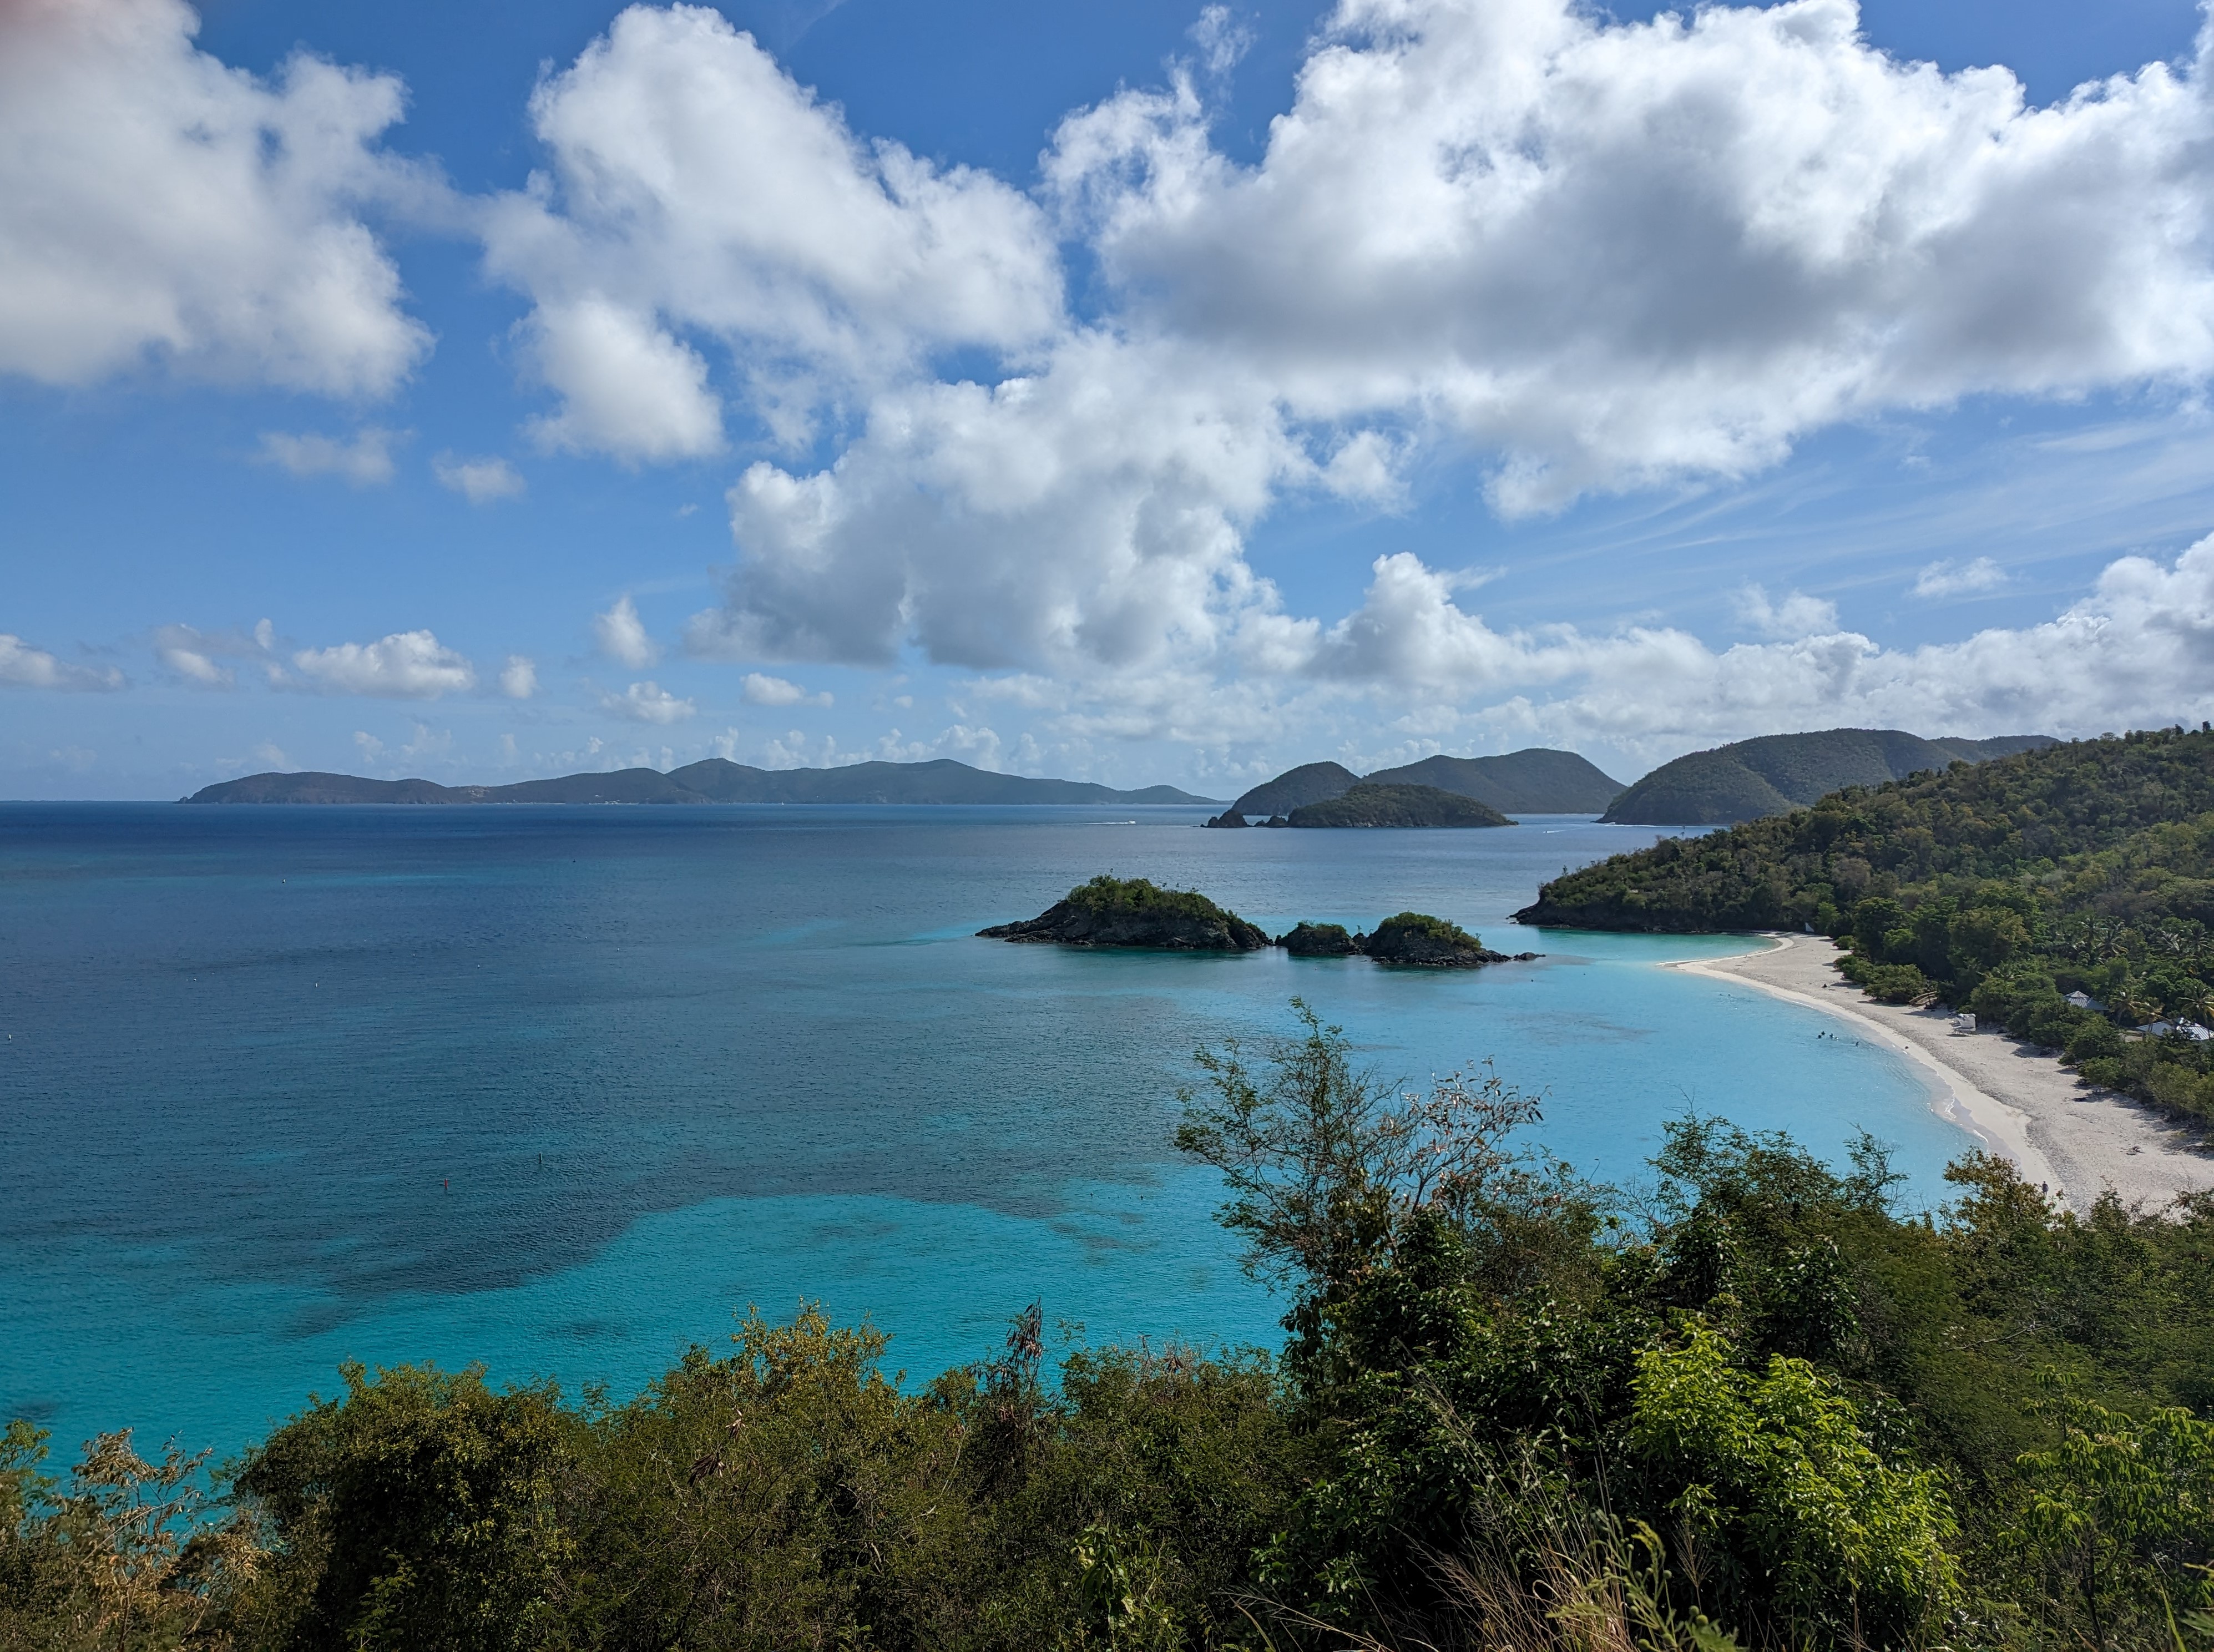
0;0;2214;797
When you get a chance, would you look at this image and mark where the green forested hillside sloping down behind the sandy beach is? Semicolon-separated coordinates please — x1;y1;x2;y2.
1517;729;2214;1118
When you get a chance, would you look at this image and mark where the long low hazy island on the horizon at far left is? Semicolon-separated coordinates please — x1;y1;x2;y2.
179;757;1216;804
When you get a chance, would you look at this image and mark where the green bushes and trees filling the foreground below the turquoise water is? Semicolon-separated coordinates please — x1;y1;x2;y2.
0;1012;2214;1652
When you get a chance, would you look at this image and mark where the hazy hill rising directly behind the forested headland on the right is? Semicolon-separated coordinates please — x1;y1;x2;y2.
1601;729;2059;826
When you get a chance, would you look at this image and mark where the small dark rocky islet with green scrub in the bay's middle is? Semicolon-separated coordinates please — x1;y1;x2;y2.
977;872;1536;970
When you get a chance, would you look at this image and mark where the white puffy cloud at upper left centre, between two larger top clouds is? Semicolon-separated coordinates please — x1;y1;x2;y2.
487;7;1060;461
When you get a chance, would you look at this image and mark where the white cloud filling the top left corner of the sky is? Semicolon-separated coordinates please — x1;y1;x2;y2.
0;0;436;396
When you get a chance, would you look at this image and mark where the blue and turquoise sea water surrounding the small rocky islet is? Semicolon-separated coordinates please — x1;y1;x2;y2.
0;804;1970;1459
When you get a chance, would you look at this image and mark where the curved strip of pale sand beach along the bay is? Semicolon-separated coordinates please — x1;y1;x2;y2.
1667;934;2214;1211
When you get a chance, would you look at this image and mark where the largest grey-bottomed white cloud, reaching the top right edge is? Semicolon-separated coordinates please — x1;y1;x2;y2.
1047;0;2214;509
